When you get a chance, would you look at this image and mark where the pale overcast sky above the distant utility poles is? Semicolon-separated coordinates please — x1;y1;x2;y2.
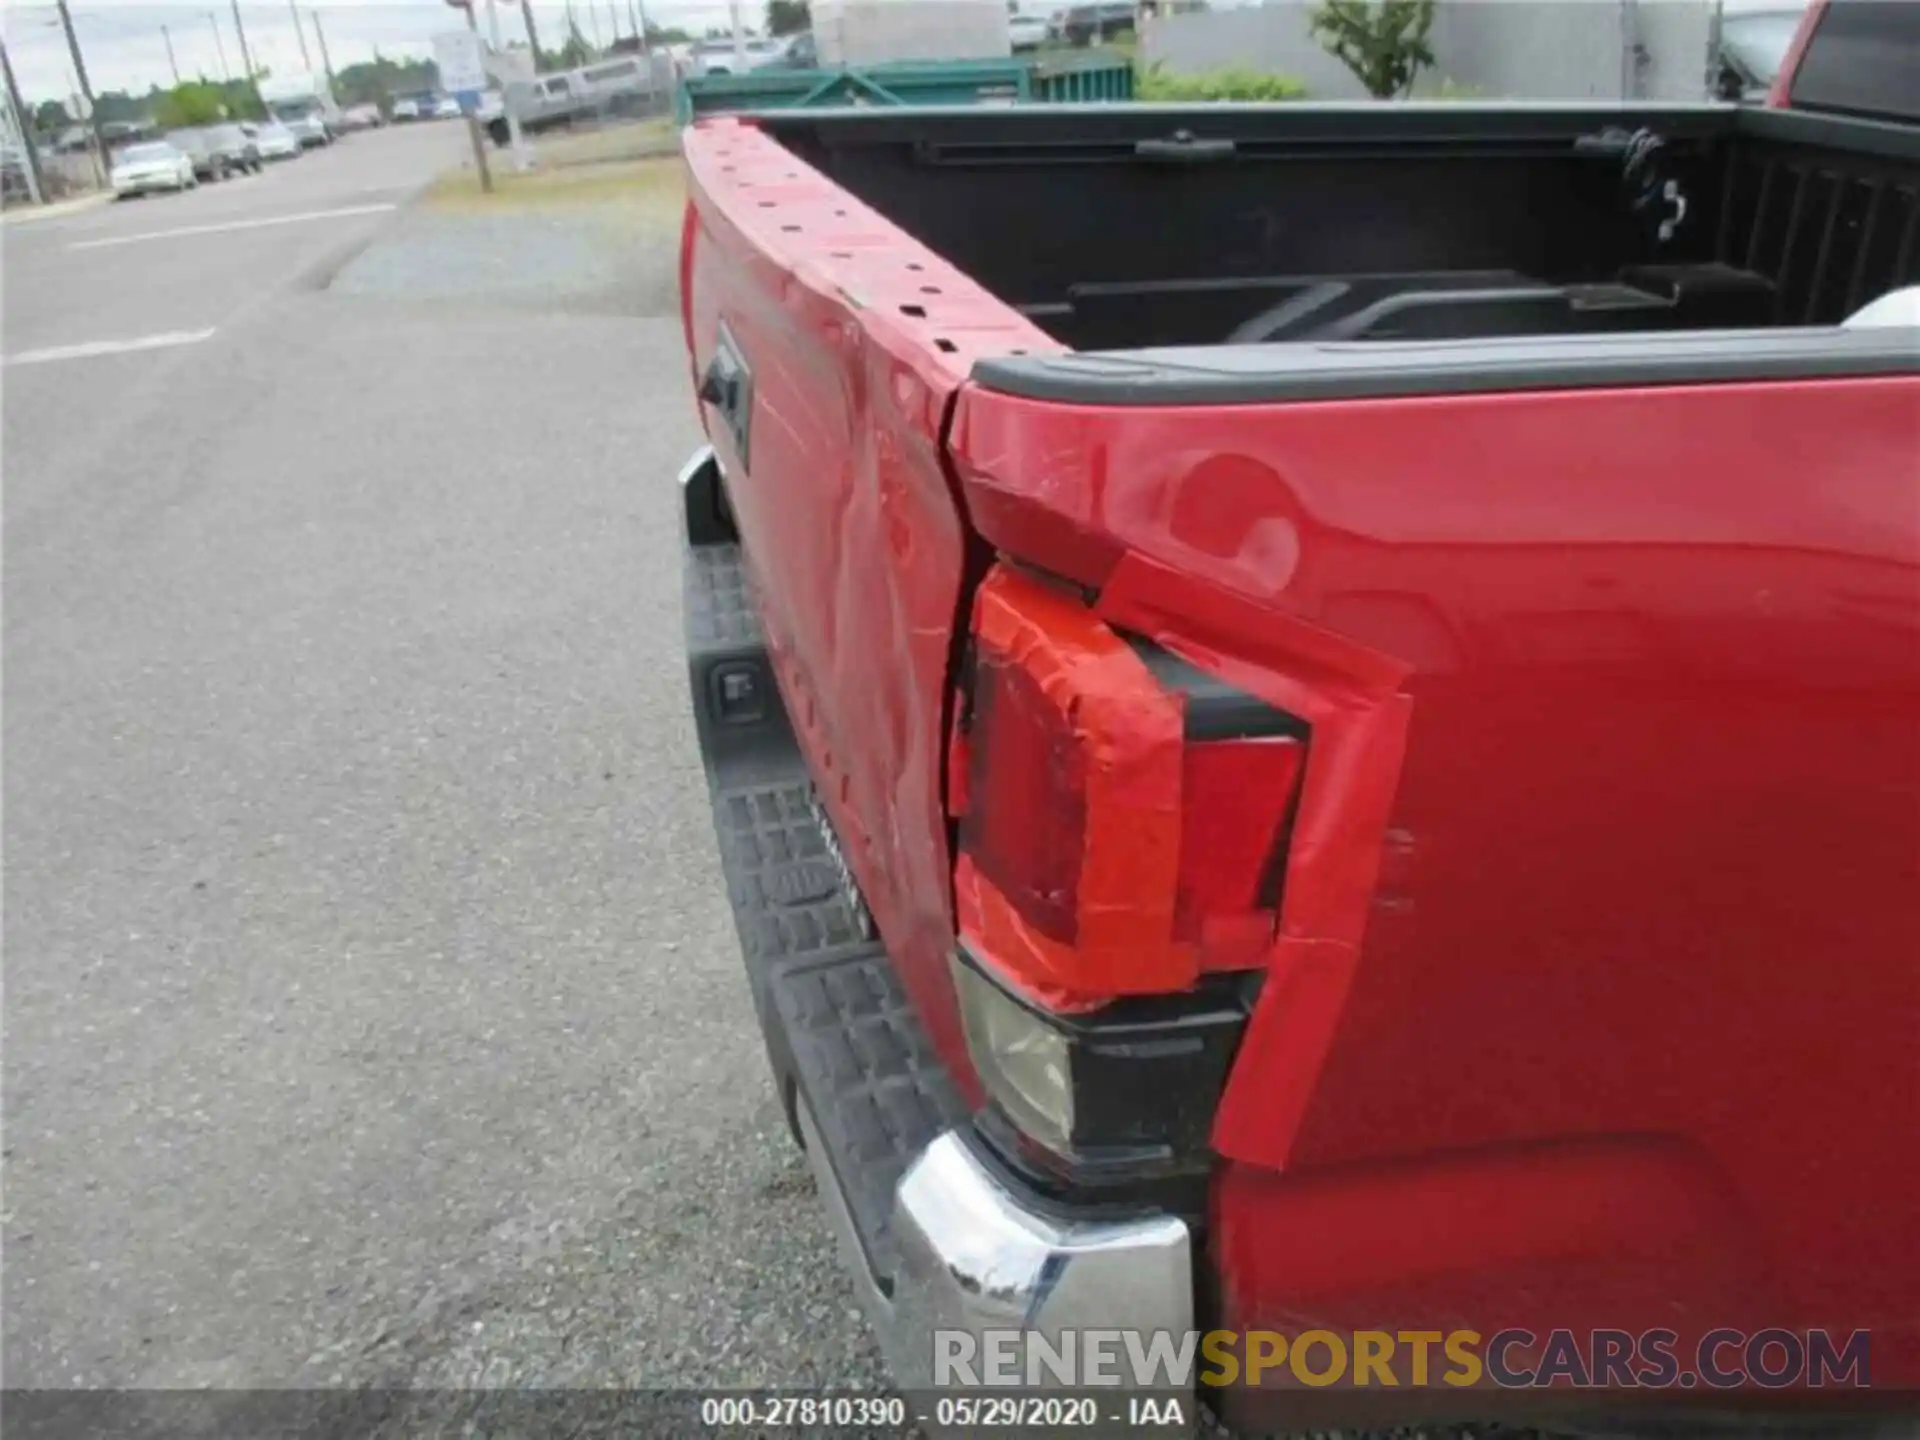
0;0;744;102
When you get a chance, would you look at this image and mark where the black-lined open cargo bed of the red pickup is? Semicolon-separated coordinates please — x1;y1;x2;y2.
756;104;1920;351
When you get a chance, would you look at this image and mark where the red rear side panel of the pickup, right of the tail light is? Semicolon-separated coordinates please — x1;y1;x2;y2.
950;376;1920;1379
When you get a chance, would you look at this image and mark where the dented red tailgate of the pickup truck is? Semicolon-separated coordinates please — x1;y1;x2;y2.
684;121;1050;1087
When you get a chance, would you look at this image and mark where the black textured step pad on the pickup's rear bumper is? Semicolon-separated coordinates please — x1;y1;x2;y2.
684;514;966;1294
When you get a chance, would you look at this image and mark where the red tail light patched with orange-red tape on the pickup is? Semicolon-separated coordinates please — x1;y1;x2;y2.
950;566;1306;1010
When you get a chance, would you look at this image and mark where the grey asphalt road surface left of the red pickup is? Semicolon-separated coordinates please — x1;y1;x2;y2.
0;125;879;1388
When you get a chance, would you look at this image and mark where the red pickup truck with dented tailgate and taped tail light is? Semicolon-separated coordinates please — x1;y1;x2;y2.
682;0;1920;1432
